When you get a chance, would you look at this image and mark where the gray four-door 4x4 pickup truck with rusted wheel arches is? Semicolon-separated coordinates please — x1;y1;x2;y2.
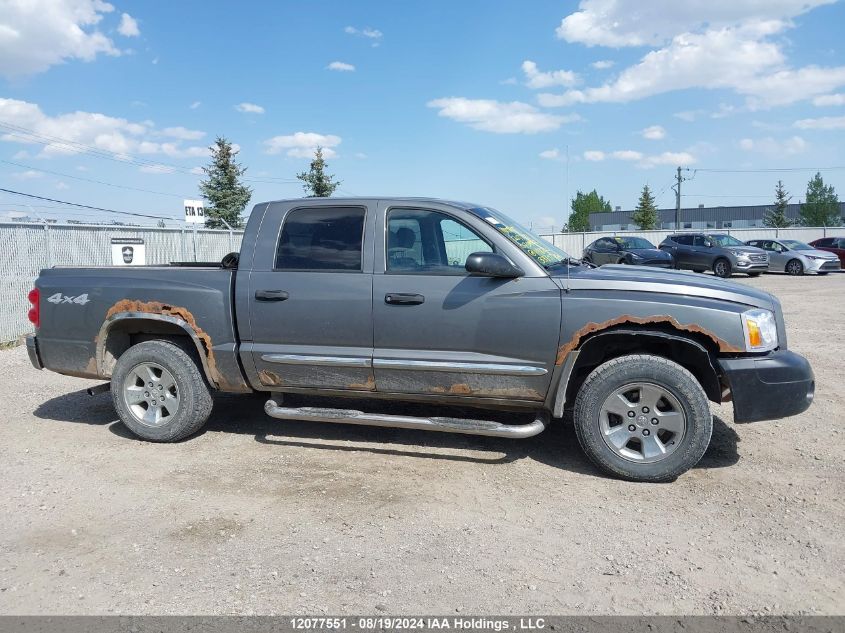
27;198;814;481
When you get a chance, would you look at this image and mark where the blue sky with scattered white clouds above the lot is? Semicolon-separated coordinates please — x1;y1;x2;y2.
0;0;845;227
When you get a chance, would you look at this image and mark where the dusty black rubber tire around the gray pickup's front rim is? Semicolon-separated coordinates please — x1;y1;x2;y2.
574;354;713;482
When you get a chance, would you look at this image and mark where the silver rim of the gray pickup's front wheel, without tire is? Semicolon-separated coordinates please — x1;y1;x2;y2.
599;382;687;464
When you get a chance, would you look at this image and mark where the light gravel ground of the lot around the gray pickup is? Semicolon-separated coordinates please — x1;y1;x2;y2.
0;273;845;614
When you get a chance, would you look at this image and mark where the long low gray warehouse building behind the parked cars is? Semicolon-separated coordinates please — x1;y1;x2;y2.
590;202;845;231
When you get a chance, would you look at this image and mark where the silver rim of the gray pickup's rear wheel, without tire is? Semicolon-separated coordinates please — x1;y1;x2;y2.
123;363;180;427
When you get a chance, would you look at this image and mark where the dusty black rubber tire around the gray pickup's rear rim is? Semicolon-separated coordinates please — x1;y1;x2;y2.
111;341;213;442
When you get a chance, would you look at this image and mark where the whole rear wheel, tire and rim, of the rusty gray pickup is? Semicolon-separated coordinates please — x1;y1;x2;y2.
111;341;212;442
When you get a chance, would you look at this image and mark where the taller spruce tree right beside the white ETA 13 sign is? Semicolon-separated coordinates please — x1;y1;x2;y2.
200;136;252;229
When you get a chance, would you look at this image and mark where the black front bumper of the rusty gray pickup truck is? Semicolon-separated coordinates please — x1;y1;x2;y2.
719;350;816;422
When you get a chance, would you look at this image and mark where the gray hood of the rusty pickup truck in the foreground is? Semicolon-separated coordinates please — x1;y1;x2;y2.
552;262;777;310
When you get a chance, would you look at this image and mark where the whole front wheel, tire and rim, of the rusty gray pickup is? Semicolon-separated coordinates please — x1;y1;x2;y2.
574;355;713;482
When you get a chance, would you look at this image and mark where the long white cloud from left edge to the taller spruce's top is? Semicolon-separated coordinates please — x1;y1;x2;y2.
0;98;208;158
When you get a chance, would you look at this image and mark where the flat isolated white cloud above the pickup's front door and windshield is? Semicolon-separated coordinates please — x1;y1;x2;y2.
426;97;580;134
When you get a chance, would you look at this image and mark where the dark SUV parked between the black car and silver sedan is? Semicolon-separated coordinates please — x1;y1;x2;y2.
659;233;769;277
